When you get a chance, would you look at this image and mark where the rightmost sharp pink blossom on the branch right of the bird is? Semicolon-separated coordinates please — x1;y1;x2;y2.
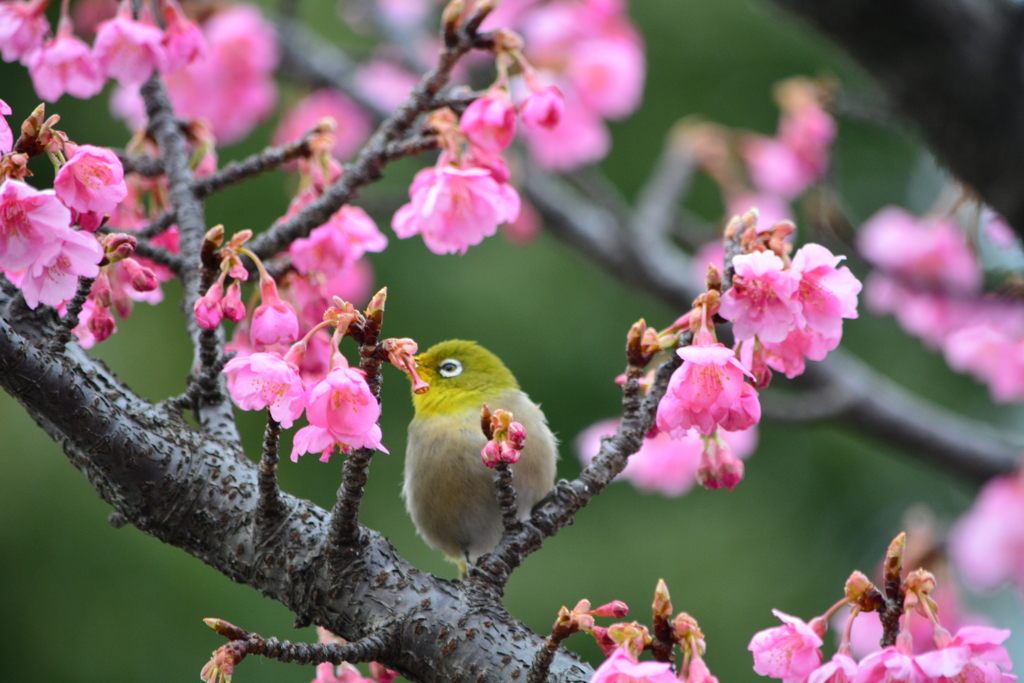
786;244;861;341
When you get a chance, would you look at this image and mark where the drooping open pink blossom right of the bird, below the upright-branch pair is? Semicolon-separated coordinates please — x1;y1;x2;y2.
657;333;761;437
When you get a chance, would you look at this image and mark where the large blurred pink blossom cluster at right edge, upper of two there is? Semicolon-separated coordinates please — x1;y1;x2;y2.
857;207;1024;402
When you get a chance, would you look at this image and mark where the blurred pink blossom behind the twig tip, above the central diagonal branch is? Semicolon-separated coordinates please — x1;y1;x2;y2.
273;89;373;160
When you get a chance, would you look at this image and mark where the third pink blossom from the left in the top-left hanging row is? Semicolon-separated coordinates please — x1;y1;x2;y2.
92;0;165;86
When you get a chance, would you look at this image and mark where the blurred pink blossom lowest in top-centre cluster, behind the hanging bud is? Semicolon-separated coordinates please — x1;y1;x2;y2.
522;87;611;173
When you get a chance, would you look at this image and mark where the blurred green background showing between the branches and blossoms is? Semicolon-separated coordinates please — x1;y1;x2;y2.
0;0;1022;683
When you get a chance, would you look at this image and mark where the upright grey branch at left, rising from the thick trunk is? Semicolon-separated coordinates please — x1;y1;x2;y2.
141;75;239;440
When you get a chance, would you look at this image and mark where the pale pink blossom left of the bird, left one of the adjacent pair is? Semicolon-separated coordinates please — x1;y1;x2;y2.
224;353;305;429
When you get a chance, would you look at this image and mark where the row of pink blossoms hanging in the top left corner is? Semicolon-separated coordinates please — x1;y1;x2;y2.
0;0;206;102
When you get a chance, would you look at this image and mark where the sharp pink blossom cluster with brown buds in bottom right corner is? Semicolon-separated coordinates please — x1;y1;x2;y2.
749;535;1017;683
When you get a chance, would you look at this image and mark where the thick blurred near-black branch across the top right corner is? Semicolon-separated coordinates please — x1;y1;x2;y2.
761;0;1024;240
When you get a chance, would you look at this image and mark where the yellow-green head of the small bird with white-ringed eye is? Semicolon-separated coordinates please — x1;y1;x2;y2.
413;339;519;418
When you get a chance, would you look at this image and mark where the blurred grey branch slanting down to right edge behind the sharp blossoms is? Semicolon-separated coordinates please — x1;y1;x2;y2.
523;162;1024;481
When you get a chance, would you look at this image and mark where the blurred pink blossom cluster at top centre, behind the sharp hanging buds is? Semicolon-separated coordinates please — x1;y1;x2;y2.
484;0;646;172
